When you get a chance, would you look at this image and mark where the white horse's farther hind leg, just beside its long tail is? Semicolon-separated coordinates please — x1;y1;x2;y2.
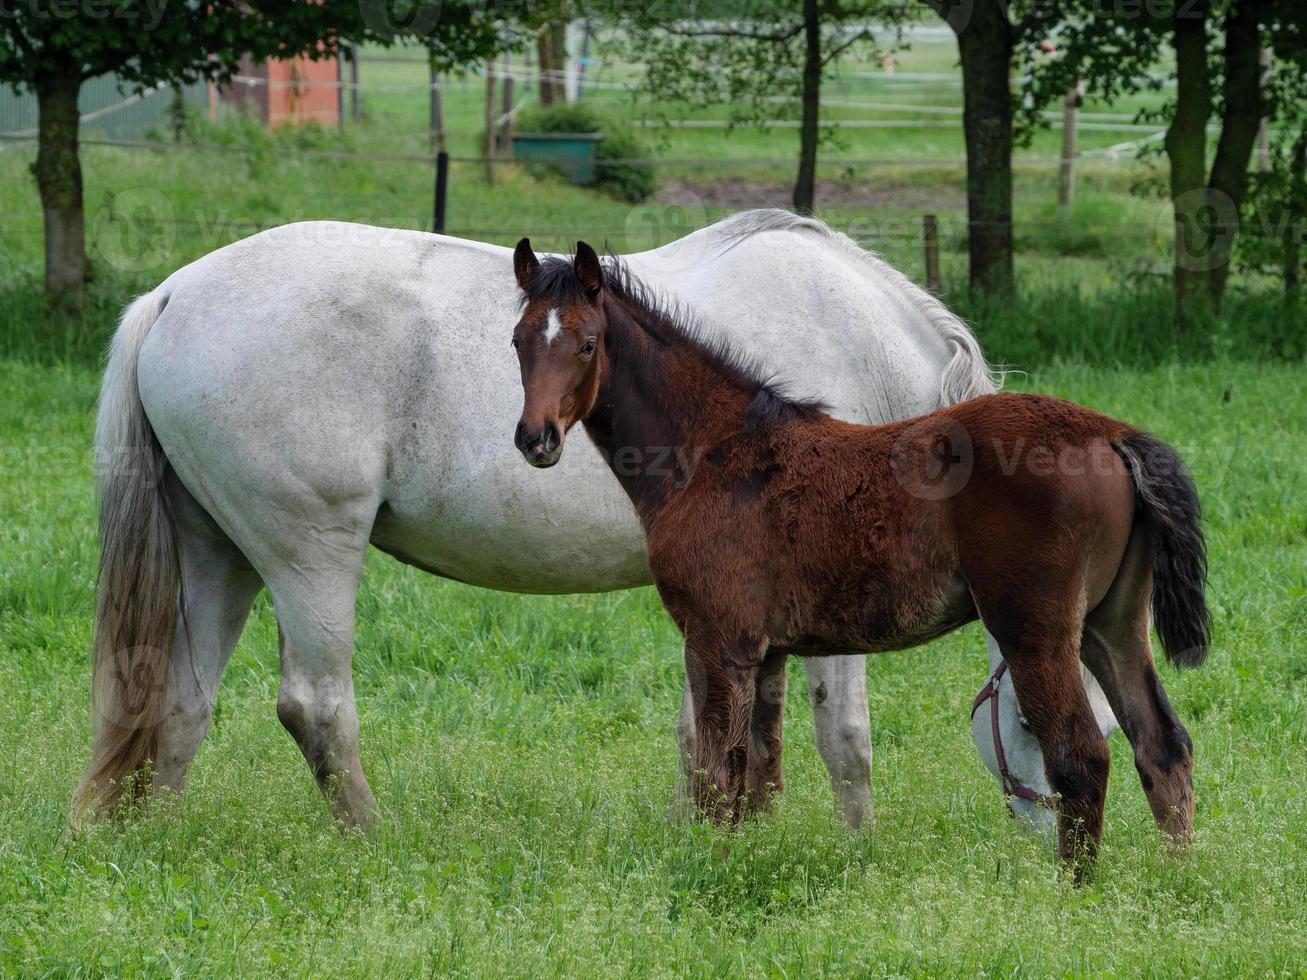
156;481;263;793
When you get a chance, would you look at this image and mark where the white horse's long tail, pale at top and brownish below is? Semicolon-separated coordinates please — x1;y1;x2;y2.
71;290;182;826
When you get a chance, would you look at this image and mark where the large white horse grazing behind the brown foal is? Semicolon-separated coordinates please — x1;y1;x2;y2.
73;210;1082;827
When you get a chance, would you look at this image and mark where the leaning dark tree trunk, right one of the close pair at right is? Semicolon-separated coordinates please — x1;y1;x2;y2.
1208;0;1261;310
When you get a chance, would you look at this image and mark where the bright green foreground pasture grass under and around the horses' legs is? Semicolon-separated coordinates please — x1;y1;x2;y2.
0;359;1307;976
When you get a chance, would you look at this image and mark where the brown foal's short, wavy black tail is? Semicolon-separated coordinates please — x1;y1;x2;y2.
1116;431;1212;666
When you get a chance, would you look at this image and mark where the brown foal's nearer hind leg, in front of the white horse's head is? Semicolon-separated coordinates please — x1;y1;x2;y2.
985;624;1110;881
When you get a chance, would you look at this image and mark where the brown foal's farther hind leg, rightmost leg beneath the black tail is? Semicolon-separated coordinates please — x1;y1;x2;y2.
1082;529;1193;840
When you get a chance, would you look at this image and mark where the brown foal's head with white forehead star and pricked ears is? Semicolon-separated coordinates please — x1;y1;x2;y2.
512;238;606;466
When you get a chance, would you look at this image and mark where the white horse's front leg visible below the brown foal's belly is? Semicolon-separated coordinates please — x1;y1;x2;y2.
804;656;872;830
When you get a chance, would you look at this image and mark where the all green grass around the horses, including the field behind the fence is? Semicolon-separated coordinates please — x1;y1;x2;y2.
0;32;1307;976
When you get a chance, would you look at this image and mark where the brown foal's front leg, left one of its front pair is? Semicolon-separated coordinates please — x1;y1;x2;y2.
685;623;765;823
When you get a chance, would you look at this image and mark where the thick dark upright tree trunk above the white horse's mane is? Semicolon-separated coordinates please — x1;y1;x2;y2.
958;3;1016;295
